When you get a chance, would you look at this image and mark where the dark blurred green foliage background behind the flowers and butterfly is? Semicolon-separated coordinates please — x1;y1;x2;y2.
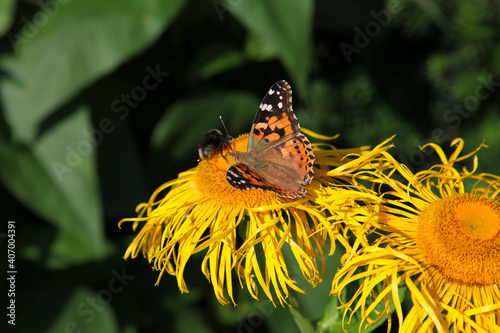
0;0;500;333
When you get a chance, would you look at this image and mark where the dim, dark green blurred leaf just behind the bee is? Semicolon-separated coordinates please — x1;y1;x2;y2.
151;91;259;160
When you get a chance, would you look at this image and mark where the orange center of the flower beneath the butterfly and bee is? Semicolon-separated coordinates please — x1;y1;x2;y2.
195;134;277;207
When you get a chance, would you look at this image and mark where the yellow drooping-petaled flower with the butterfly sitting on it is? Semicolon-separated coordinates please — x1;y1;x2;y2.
120;129;389;305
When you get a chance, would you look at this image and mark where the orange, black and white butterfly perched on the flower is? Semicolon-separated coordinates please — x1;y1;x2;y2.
226;81;315;198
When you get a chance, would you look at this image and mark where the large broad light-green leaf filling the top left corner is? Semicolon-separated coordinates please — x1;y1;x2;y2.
0;0;185;141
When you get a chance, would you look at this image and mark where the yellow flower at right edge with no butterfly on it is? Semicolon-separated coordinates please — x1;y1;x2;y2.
332;139;500;332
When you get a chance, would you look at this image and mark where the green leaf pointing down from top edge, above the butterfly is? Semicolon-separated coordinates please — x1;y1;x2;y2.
226;0;313;96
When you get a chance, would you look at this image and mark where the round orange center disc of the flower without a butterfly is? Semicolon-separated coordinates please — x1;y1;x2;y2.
417;194;500;286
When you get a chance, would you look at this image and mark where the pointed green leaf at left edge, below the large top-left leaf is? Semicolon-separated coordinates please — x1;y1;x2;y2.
0;108;107;267
